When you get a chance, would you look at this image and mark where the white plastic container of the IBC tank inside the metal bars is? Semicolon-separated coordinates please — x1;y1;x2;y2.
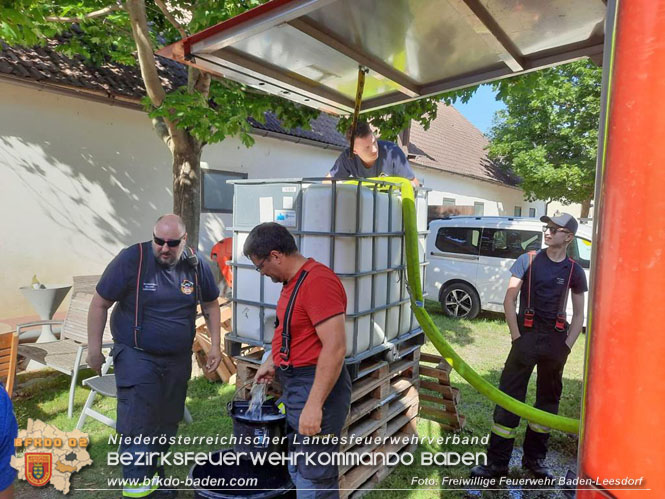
228;182;427;358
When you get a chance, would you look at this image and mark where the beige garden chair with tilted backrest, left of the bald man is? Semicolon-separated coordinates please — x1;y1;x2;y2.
16;275;113;418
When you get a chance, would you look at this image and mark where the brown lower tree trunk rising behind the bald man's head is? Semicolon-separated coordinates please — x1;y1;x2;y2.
173;135;201;249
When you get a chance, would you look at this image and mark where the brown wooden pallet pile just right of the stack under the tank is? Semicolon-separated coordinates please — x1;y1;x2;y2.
419;353;466;431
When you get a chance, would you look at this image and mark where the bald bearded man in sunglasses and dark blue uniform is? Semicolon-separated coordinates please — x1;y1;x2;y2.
87;215;221;497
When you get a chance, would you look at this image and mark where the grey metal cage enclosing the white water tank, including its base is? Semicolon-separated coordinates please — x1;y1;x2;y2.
226;178;428;364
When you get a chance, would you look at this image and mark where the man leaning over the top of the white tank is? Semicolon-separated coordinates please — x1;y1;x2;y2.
328;121;420;187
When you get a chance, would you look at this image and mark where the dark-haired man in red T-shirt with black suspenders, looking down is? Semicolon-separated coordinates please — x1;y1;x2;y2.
243;223;351;499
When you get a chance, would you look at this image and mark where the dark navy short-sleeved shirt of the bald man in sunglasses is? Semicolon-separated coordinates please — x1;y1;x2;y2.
97;243;219;354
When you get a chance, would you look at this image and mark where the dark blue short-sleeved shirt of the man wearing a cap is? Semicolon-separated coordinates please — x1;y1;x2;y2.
510;250;588;324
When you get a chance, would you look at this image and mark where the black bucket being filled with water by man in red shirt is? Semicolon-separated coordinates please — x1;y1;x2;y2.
226;399;288;454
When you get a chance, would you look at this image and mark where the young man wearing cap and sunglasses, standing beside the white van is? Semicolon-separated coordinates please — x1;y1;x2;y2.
471;213;587;478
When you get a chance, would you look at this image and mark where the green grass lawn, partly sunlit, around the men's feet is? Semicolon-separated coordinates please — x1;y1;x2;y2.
10;302;584;499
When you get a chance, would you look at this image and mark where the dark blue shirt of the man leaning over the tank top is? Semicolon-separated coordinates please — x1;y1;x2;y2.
330;140;415;180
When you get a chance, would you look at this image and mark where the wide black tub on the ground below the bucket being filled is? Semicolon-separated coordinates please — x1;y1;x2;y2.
189;449;296;499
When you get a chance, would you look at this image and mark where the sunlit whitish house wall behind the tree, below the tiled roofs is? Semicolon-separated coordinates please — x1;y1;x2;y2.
0;82;543;319
